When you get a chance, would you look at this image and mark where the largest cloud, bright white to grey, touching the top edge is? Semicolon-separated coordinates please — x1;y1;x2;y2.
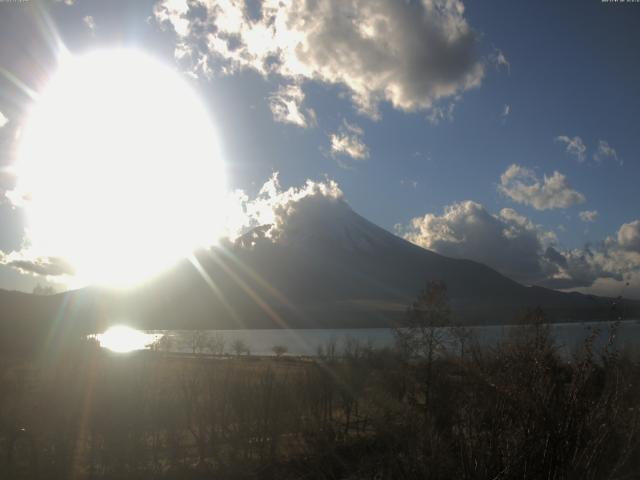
154;0;484;117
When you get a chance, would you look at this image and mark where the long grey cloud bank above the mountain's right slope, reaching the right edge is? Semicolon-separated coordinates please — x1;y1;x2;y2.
396;201;640;297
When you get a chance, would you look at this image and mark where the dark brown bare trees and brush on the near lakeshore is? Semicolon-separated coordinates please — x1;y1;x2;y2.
0;289;640;479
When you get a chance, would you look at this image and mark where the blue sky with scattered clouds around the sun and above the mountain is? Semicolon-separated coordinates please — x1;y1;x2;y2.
0;0;640;295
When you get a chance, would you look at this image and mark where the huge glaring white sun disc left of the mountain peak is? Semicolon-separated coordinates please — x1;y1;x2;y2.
14;50;226;286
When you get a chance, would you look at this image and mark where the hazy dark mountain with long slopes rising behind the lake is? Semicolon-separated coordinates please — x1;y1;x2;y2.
0;200;639;331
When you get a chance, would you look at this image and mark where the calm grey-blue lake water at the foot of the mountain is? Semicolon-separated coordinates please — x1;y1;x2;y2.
96;320;640;356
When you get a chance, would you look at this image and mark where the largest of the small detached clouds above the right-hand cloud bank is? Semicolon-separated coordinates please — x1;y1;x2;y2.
498;164;585;210
